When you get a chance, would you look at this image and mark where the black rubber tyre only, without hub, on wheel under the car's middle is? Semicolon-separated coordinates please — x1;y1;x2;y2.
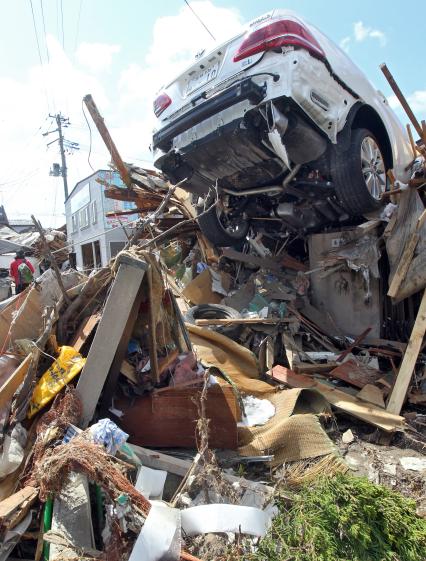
197;196;249;247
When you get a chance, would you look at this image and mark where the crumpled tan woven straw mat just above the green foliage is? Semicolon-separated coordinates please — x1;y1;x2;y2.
238;389;336;466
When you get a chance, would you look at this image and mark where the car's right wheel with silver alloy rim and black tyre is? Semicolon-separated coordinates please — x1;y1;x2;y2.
331;128;387;216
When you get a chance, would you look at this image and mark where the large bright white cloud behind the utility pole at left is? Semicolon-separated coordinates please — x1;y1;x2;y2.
0;0;242;226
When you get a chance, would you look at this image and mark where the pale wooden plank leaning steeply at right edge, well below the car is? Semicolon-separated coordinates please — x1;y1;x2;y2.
386;290;426;414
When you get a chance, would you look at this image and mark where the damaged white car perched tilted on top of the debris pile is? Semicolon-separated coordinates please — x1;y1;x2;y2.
153;10;412;246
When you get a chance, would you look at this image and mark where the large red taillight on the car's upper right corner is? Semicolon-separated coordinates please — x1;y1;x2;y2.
234;19;325;62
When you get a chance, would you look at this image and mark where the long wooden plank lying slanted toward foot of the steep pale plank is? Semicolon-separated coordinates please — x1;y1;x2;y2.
267;366;405;432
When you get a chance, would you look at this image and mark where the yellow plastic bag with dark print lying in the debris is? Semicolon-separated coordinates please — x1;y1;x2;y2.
28;345;86;419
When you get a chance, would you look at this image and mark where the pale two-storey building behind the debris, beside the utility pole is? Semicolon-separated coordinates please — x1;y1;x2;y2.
65;170;138;270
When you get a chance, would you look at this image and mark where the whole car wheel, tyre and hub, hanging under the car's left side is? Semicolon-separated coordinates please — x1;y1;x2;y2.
198;192;249;247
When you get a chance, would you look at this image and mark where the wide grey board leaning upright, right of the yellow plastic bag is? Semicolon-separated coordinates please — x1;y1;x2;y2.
77;260;147;428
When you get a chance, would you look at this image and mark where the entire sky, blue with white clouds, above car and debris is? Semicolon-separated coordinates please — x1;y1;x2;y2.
0;0;426;225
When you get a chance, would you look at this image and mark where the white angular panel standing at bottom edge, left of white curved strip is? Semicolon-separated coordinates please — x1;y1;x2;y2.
129;502;181;561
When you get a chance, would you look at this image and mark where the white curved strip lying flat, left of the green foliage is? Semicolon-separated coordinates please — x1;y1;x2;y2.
182;504;271;537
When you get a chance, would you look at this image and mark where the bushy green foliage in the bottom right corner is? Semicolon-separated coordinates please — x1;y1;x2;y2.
244;475;426;561
